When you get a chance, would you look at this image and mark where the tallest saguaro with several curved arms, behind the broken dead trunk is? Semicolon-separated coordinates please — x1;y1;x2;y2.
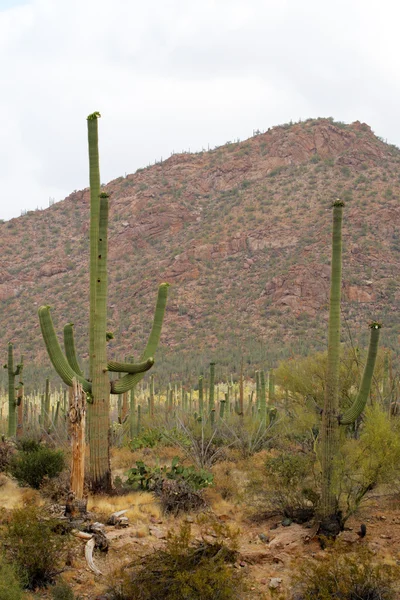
39;112;168;491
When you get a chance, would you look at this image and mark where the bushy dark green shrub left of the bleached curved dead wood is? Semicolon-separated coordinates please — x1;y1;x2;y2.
3;506;67;589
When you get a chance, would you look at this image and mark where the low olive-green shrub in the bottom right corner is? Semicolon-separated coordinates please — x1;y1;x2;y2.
293;542;399;600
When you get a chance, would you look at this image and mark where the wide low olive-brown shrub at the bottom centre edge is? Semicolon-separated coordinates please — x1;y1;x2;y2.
108;517;243;600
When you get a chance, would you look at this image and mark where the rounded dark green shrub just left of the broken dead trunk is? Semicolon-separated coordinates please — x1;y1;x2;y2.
9;445;65;489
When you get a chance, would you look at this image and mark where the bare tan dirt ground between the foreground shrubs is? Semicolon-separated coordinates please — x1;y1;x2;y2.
0;481;400;600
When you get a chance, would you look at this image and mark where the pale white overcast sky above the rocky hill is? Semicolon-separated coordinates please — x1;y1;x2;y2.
0;0;400;219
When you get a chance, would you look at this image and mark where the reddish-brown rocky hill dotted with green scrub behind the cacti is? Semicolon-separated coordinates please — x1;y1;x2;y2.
0;119;400;386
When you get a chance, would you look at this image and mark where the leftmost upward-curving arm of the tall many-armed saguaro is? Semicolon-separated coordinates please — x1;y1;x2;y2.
38;306;92;393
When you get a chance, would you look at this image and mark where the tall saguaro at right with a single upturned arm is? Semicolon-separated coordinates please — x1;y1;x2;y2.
321;201;381;532
